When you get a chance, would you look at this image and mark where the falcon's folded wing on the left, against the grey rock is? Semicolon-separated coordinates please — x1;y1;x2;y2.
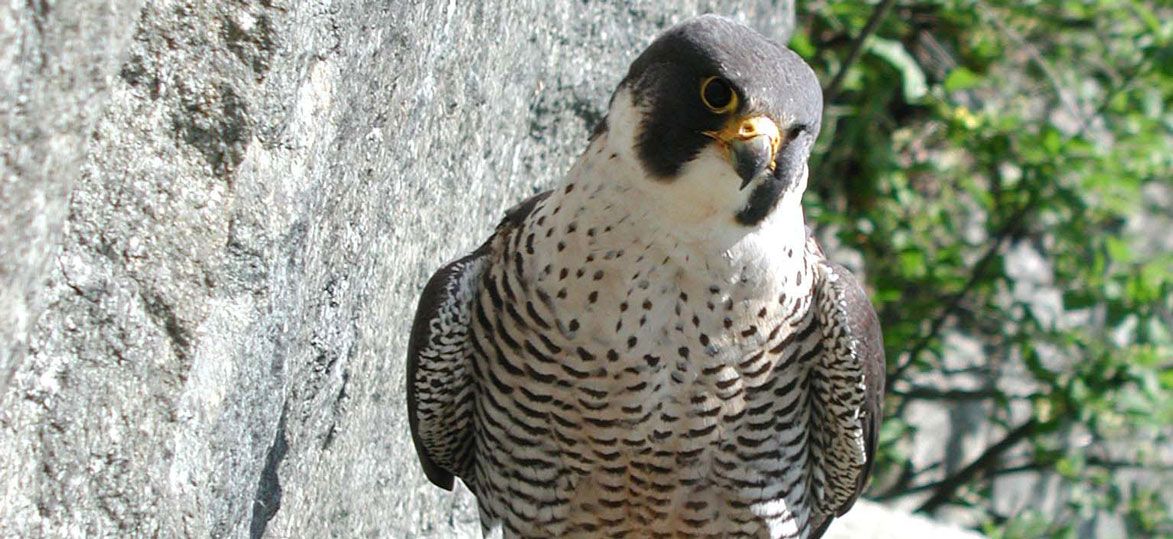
407;192;549;490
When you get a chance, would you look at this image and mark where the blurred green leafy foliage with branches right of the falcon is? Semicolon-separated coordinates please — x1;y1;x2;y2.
791;0;1173;538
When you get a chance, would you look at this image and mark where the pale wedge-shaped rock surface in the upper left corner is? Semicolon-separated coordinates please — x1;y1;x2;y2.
0;0;140;394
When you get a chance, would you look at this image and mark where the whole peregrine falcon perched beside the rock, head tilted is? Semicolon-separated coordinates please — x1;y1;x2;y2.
407;15;884;538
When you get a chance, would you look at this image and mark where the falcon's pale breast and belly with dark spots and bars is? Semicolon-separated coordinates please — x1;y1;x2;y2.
462;189;828;538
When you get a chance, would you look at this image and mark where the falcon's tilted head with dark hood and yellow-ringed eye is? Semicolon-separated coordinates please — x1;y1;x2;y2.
605;15;822;228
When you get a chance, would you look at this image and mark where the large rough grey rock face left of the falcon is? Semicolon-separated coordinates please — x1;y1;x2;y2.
0;0;971;538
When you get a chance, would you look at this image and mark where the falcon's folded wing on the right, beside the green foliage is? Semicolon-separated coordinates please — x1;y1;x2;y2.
811;261;884;538
